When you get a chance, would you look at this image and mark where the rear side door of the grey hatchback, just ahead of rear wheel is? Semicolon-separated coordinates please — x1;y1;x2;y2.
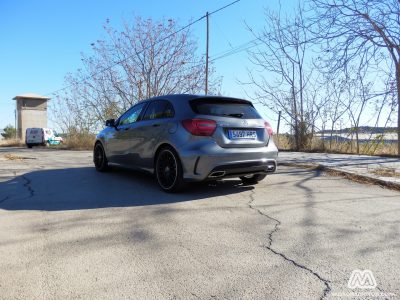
133;100;174;170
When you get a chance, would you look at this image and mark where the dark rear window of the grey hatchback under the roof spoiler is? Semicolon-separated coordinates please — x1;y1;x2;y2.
190;98;261;119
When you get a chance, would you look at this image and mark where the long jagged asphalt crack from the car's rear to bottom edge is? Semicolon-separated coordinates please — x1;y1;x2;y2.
247;190;331;300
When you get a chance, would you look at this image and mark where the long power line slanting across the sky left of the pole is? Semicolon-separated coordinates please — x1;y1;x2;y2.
45;0;240;96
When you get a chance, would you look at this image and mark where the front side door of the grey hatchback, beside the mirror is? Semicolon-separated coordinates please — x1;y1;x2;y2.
107;103;147;165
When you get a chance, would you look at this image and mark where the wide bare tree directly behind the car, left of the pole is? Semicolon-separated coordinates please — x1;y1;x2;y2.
55;17;219;131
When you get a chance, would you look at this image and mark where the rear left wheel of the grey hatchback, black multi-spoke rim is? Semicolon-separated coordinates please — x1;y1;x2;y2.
154;147;185;193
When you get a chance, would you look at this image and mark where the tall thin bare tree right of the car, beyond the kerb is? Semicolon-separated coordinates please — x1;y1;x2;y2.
247;7;321;150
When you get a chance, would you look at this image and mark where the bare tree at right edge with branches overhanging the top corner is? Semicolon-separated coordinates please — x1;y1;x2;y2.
311;0;400;155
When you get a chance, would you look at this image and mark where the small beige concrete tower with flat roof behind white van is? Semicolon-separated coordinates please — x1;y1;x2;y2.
13;93;50;140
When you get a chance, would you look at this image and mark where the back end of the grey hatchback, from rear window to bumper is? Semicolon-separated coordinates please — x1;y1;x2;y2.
178;97;278;181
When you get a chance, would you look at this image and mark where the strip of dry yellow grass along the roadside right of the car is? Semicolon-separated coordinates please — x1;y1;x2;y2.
274;134;397;156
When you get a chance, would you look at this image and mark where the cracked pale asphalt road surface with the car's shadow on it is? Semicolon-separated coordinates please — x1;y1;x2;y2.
0;148;400;299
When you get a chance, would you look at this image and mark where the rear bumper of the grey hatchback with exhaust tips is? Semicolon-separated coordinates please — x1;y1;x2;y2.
178;140;278;181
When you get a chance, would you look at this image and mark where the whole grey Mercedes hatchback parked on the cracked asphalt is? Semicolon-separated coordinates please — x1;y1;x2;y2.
93;94;278;192
